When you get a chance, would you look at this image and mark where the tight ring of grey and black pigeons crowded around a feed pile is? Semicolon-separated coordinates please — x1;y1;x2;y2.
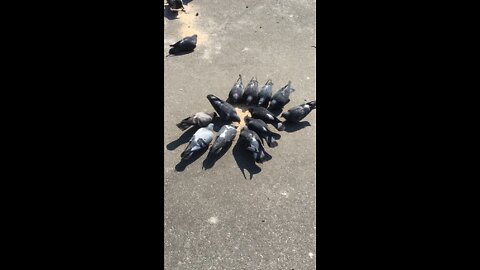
177;75;317;163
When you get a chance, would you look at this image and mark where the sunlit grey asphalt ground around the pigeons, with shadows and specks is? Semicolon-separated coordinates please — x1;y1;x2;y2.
164;0;317;270
